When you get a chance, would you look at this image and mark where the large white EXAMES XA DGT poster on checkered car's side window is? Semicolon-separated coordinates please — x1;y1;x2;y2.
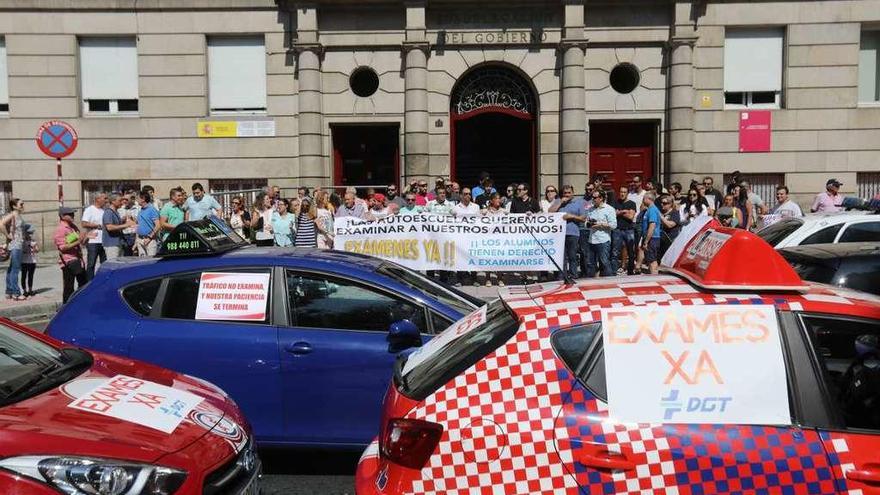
602;305;791;425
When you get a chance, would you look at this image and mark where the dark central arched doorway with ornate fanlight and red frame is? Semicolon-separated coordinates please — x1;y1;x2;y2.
449;65;537;192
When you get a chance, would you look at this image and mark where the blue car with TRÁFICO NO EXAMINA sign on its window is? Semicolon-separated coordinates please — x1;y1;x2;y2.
47;222;479;448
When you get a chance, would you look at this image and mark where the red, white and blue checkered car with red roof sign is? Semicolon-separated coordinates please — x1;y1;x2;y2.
356;224;880;495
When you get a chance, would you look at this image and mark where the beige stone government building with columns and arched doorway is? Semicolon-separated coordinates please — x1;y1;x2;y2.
0;0;880;221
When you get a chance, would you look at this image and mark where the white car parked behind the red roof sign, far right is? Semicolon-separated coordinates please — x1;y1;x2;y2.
758;211;880;249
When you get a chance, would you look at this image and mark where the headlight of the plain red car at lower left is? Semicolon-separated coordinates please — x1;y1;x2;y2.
0;456;186;495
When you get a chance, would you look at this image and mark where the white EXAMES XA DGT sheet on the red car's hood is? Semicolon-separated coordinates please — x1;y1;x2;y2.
67;375;202;433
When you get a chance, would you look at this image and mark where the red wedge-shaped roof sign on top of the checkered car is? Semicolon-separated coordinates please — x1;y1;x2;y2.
664;220;807;291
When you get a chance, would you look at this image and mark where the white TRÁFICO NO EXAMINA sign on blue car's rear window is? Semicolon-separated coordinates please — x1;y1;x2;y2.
196;272;269;321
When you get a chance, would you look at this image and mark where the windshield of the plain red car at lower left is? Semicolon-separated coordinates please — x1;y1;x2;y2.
0;323;91;407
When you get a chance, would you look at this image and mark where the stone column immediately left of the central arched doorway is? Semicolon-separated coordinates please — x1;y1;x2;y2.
403;42;430;183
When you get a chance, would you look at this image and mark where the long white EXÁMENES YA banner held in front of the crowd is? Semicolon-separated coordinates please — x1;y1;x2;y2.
333;213;565;272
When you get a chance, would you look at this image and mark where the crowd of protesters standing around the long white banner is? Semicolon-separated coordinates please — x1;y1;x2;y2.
0;172;844;302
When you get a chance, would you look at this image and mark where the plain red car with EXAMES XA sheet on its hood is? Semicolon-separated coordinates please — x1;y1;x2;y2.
0;319;261;495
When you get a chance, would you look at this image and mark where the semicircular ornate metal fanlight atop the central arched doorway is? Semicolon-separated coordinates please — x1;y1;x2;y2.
452;67;535;115
